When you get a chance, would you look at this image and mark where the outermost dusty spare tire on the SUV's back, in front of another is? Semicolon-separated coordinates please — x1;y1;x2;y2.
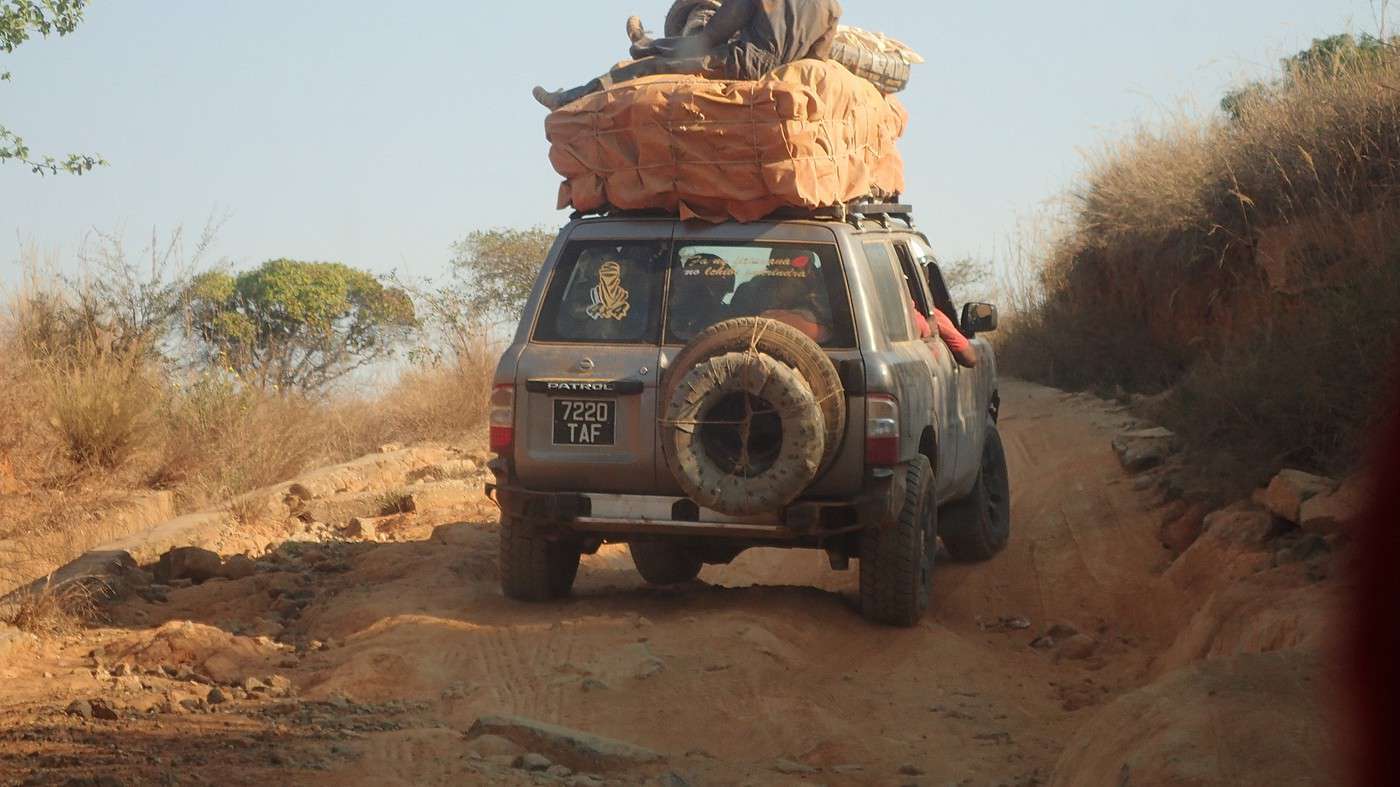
661;350;825;517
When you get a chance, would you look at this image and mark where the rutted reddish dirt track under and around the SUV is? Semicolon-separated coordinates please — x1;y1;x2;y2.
0;382;1322;786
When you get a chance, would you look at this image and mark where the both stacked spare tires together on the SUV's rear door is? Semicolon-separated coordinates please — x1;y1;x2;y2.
659;318;846;515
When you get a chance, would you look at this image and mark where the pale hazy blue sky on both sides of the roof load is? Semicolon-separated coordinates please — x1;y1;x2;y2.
0;0;1375;281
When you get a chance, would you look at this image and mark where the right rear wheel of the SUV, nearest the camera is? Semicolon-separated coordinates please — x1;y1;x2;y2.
860;457;938;627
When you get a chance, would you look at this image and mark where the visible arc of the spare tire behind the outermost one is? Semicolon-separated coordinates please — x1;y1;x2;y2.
662;316;846;475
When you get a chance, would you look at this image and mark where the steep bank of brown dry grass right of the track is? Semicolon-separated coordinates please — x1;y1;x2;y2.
998;44;1400;485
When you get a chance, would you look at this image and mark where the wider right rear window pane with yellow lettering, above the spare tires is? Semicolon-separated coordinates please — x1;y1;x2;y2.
666;241;855;347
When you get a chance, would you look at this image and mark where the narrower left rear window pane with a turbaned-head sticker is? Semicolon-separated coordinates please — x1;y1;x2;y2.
535;241;671;344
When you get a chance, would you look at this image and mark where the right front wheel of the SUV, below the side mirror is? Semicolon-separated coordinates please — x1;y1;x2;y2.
939;424;1011;563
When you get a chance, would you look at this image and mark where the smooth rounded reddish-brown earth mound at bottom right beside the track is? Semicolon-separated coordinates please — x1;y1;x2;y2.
1050;651;1337;787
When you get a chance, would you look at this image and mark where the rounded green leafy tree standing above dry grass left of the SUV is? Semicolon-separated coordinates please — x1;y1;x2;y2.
185;259;417;392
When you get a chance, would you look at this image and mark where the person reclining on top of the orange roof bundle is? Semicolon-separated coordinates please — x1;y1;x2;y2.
533;0;841;111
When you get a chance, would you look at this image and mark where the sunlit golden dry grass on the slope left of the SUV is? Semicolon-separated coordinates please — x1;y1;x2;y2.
0;268;497;633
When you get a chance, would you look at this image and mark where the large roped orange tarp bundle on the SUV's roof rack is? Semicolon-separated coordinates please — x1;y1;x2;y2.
545;60;909;221
